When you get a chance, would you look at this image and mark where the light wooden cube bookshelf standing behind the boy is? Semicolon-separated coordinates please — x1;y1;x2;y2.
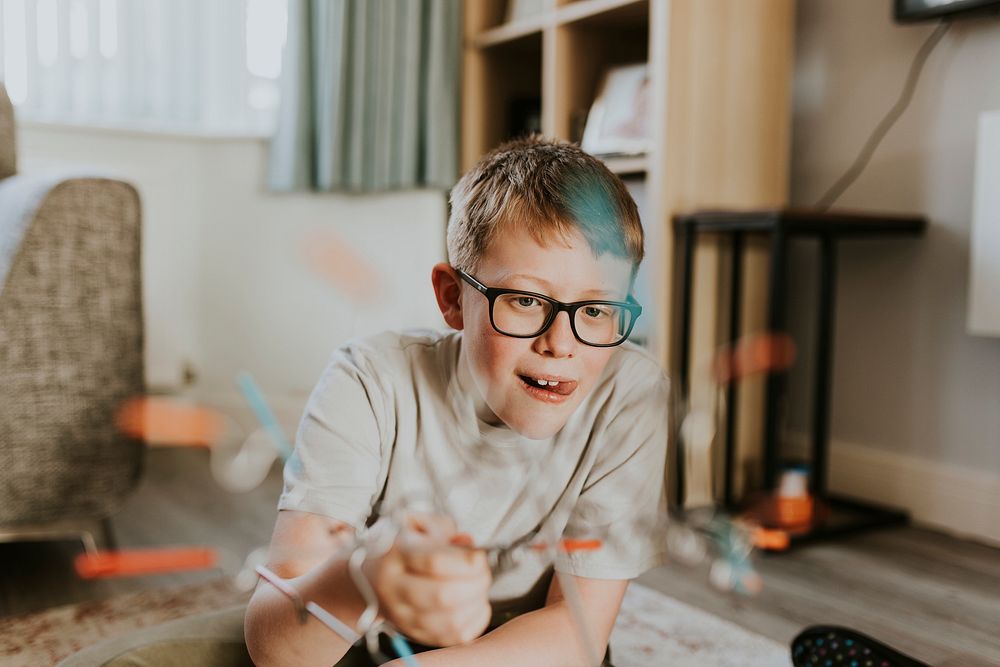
461;0;794;504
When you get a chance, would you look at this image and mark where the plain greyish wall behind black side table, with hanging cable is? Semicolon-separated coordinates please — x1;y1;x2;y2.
790;0;1000;539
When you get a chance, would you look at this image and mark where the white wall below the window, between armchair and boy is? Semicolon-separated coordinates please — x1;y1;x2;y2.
19;124;446;412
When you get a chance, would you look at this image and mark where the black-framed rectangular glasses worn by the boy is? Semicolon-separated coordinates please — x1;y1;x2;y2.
455;269;642;347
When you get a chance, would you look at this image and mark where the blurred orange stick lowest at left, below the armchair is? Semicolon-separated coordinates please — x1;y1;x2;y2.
73;547;219;579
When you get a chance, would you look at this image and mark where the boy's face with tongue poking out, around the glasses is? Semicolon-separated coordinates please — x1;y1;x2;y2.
435;231;632;440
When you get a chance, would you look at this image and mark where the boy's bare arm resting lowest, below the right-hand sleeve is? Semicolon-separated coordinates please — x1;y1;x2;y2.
389;574;629;667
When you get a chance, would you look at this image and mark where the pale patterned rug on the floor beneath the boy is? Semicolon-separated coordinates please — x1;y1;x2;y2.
0;579;790;667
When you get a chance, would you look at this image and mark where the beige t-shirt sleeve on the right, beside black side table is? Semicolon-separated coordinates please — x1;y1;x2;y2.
556;364;670;579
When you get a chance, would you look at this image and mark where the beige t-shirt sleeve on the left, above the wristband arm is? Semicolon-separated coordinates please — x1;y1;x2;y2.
278;345;391;528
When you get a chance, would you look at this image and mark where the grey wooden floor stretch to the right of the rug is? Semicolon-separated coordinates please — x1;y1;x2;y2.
640;528;1000;667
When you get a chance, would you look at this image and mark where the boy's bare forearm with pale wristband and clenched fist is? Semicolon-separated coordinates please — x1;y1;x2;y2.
244;510;490;667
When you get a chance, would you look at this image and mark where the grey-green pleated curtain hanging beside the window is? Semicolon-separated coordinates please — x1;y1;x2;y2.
268;0;461;192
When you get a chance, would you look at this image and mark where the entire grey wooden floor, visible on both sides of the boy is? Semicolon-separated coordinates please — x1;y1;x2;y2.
0;449;1000;667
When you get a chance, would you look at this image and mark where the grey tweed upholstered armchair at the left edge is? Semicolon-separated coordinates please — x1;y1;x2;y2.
0;86;143;546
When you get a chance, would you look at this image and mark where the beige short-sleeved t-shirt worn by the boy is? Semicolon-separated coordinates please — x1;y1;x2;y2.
278;331;669;612
